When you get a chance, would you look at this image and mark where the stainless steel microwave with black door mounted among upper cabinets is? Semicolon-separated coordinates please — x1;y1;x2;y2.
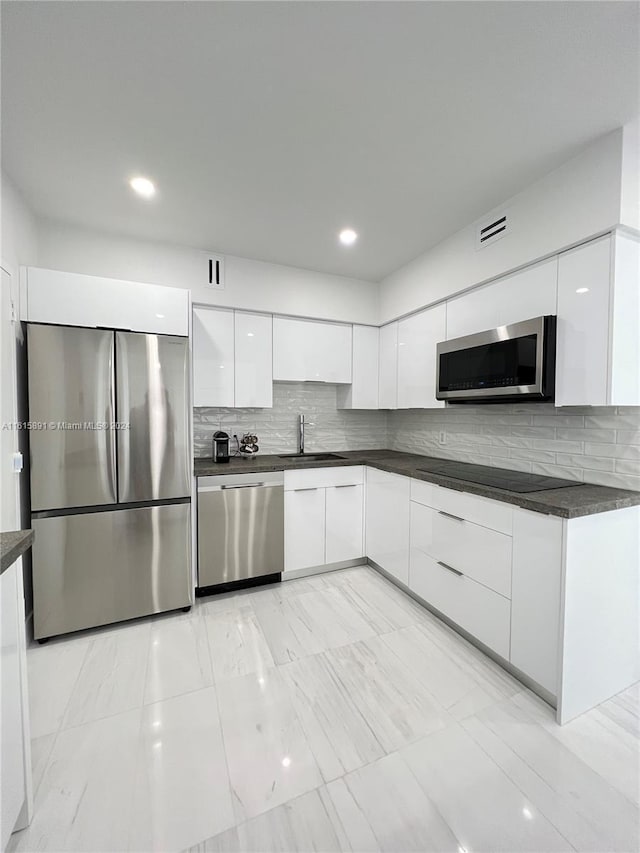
436;316;556;403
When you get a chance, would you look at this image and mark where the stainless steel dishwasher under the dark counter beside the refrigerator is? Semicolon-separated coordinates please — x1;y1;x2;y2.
198;472;284;590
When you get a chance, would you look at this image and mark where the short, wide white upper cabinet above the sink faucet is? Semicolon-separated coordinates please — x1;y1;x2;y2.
273;317;351;384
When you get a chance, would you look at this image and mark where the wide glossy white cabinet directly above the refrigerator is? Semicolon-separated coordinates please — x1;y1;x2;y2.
21;267;190;337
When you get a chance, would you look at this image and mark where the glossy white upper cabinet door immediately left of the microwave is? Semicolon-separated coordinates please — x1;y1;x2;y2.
398;302;447;409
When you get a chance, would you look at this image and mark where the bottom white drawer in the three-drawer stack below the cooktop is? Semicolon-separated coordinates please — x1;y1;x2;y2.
409;548;511;660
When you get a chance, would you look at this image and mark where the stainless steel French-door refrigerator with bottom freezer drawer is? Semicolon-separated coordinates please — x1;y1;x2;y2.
27;324;192;639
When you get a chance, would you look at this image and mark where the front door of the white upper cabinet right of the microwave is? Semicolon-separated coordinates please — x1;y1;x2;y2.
556;237;611;406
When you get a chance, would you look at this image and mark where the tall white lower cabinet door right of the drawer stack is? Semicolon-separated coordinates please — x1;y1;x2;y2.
509;507;562;696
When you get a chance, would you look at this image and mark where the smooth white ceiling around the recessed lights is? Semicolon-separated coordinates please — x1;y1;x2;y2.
2;0;640;280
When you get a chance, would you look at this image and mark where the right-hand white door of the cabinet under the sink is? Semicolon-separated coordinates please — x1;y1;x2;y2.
326;486;364;563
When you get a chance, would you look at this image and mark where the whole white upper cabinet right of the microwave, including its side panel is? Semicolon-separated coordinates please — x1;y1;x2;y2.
556;234;640;406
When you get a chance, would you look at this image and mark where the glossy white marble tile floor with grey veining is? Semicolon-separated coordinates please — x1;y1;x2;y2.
9;567;640;853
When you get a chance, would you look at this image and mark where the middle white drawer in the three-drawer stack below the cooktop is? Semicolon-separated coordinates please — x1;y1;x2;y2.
411;503;512;598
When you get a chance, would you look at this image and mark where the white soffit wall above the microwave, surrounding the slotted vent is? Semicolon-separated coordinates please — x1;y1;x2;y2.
380;128;637;323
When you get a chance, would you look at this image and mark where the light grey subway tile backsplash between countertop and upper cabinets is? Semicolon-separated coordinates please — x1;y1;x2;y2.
194;390;640;490
